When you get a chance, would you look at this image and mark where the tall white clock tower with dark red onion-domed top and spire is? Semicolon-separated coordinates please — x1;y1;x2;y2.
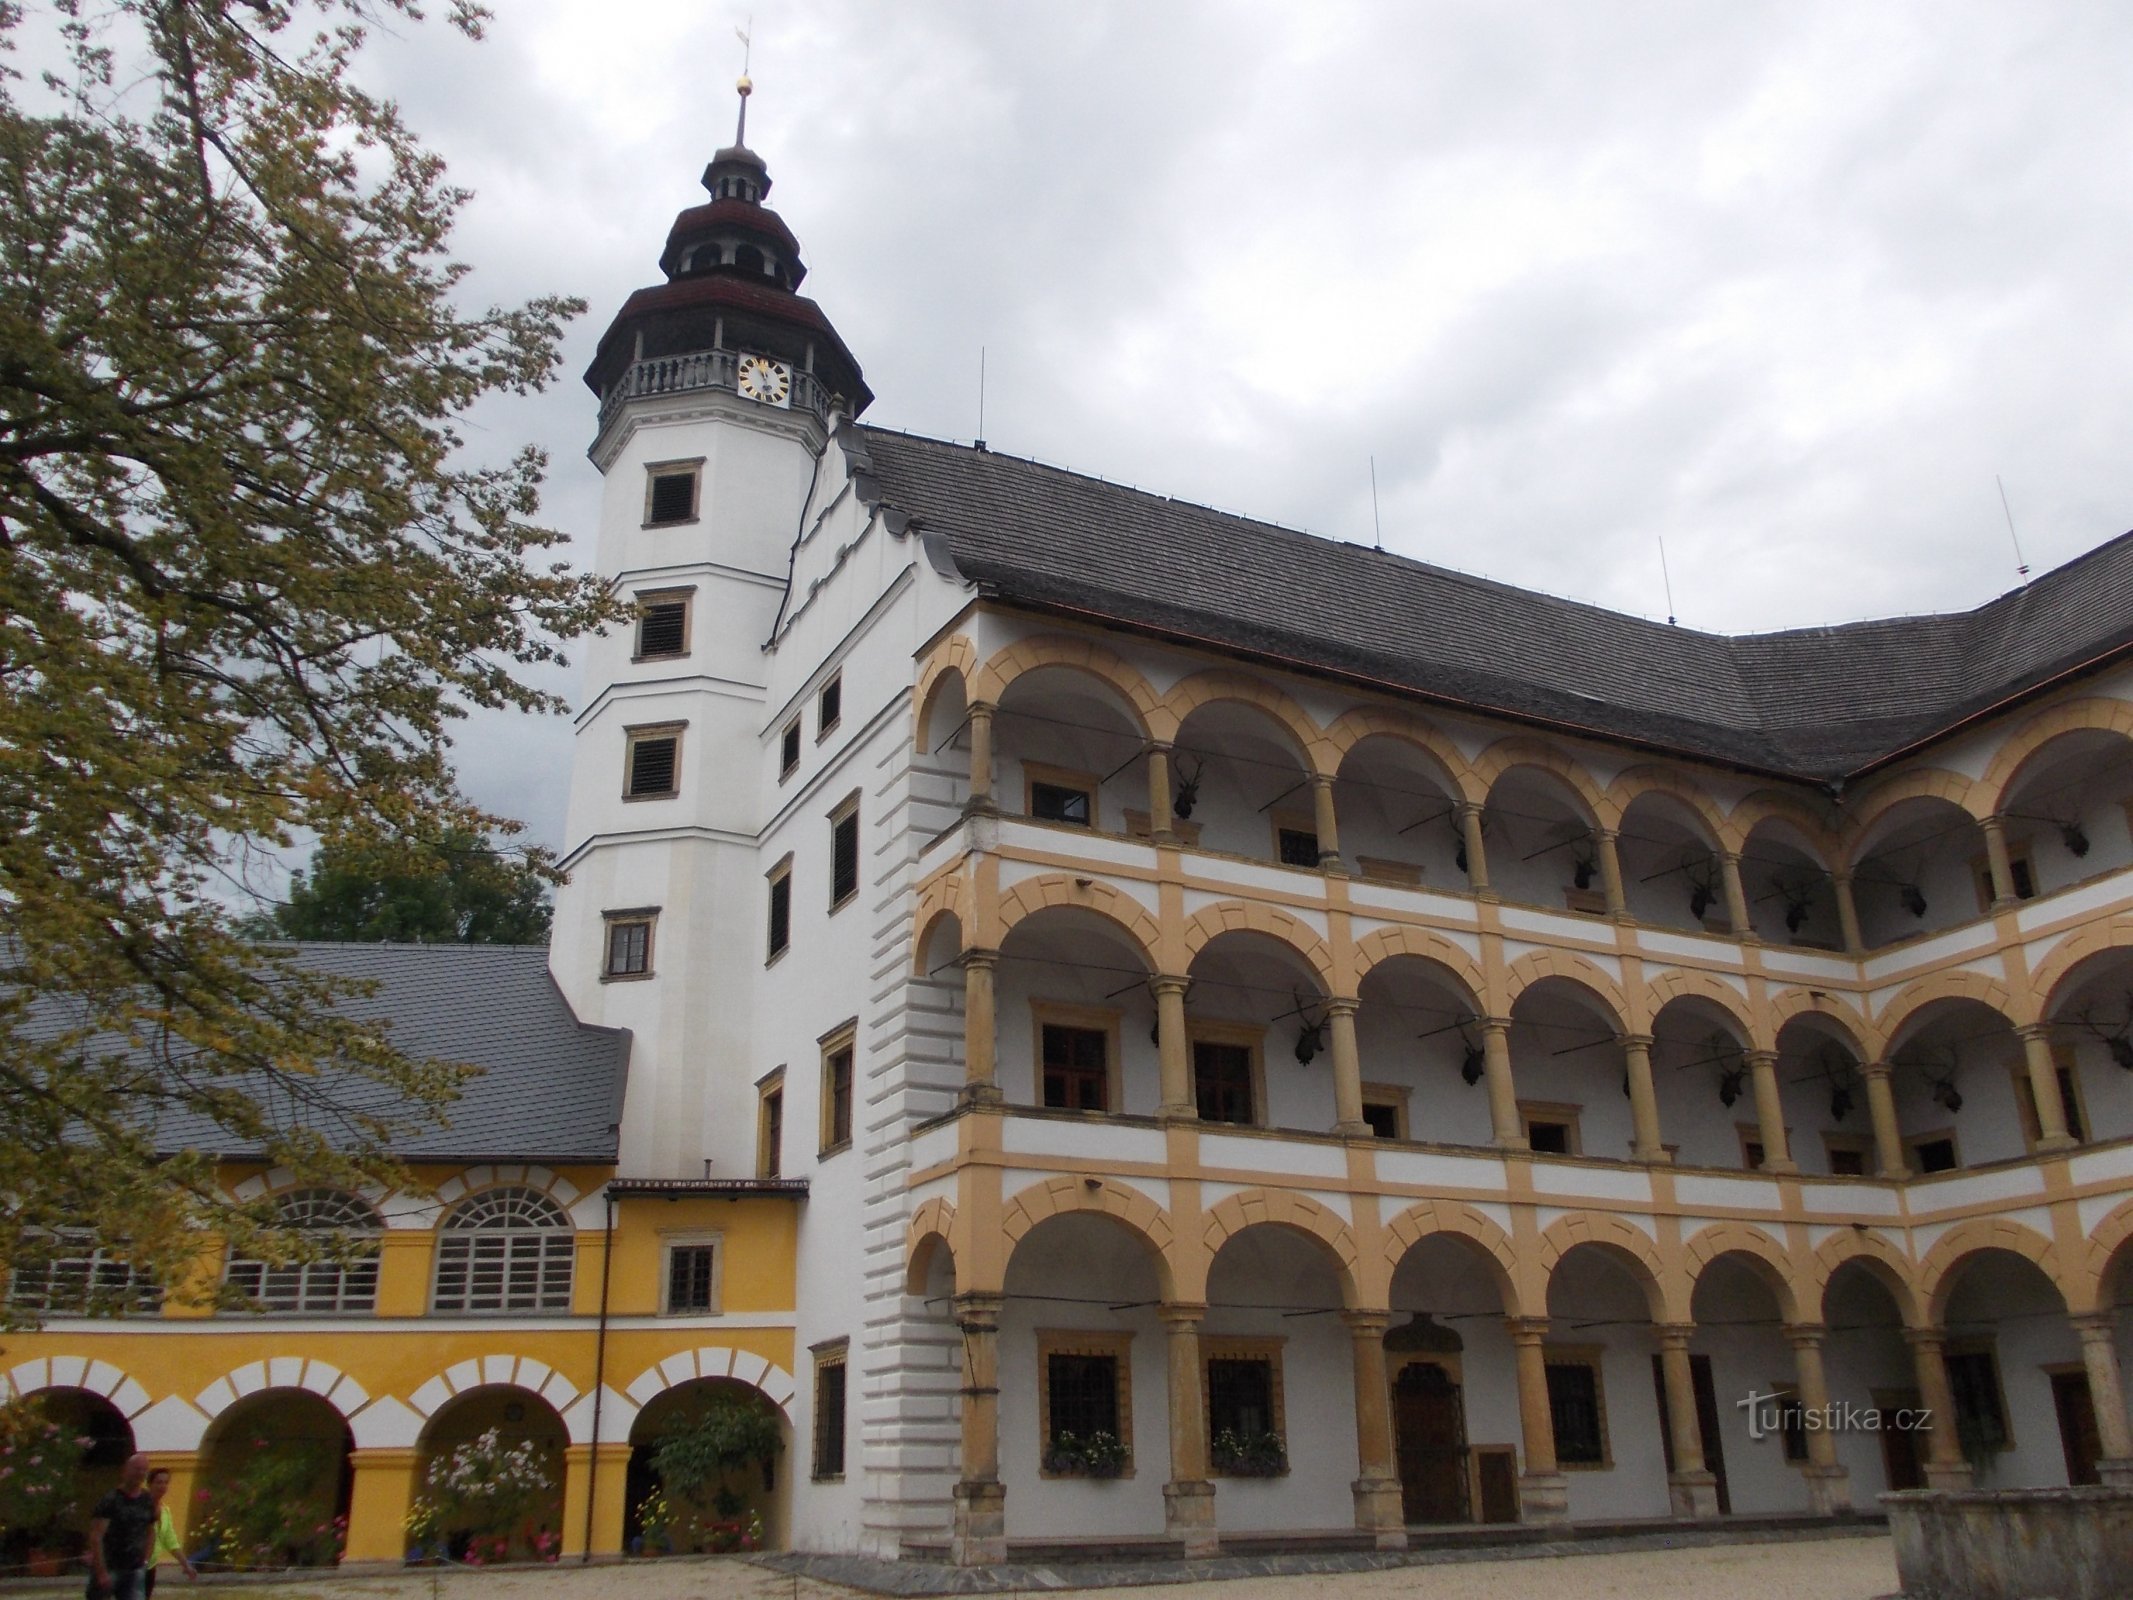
550;87;872;1178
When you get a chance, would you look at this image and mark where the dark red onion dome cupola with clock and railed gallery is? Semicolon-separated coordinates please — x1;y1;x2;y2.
584;77;875;429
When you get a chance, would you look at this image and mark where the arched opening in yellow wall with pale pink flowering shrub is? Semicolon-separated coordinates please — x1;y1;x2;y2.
414;1382;570;1564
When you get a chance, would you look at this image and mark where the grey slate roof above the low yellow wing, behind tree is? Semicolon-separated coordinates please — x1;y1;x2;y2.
156;943;629;1165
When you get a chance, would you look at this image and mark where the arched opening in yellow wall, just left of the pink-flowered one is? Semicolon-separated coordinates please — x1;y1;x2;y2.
200;1389;356;1570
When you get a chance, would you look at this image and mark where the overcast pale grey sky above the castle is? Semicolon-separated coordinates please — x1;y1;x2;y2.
354;0;2133;845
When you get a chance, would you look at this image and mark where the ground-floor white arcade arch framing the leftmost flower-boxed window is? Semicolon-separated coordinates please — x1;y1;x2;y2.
998;1212;1171;1538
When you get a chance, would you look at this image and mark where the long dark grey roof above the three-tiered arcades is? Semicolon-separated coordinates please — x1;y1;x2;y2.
847;427;2133;783
